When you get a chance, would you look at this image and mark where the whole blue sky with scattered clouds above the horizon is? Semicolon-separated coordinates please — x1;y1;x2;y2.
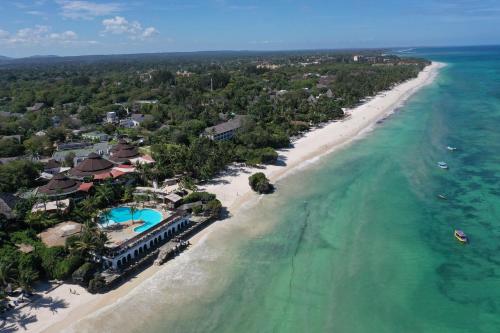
0;0;500;57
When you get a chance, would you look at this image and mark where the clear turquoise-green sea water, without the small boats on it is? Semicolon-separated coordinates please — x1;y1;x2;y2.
72;47;500;333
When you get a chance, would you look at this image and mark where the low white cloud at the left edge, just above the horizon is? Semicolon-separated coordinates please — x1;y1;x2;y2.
0;25;85;45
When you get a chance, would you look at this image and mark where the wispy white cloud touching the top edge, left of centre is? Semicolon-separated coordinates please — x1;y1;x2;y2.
57;0;122;20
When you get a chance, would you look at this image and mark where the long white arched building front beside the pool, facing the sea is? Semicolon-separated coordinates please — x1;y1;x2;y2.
100;212;190;269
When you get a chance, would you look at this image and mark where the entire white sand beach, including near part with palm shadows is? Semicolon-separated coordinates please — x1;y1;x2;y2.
0;63;444;332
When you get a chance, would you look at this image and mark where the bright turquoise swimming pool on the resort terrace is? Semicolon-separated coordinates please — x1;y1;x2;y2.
101;207;163;233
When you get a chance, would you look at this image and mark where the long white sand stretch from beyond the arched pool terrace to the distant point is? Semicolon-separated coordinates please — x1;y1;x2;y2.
202;63;444;213
